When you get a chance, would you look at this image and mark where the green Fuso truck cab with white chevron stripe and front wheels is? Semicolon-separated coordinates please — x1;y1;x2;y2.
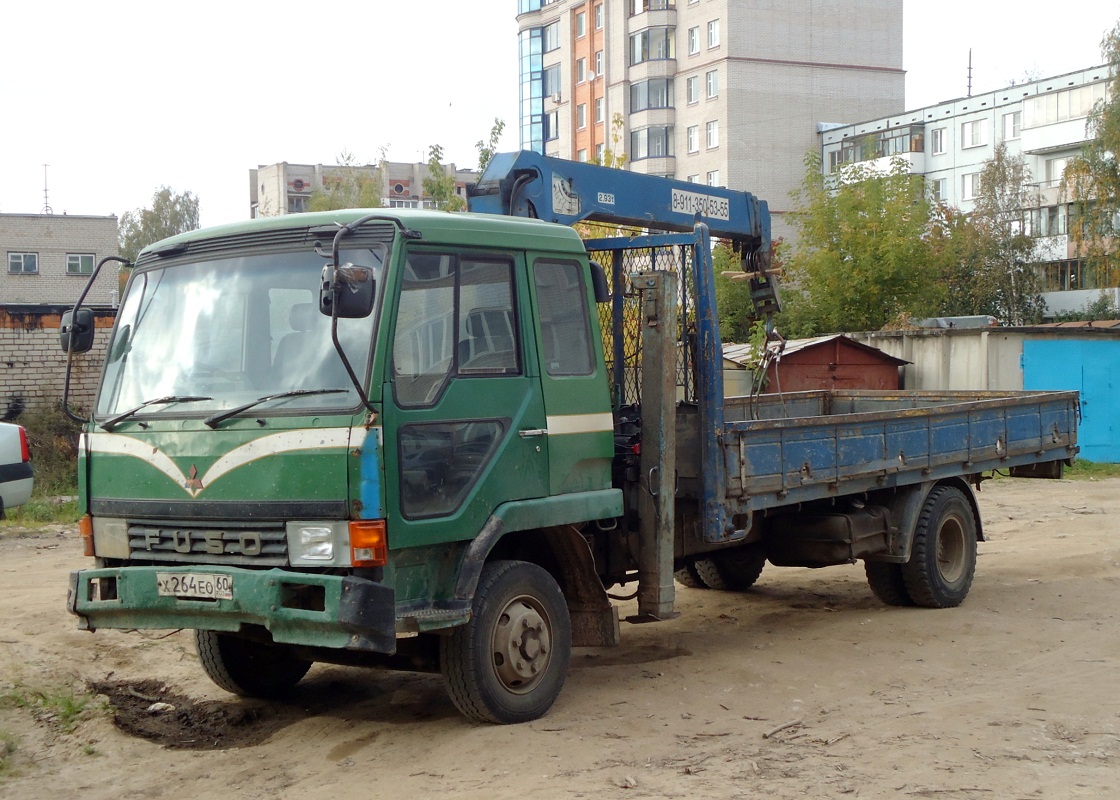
68;210;623;722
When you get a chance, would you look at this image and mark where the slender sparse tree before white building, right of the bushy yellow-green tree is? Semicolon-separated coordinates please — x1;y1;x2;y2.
942;142;1045;325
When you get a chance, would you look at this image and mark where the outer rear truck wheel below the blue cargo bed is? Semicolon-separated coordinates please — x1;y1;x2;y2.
902;486;977;608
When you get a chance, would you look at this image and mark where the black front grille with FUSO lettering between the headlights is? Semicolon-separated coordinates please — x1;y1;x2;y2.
129;522;288;567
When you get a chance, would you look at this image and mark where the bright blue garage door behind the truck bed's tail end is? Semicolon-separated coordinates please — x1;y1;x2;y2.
1023;341;1120;463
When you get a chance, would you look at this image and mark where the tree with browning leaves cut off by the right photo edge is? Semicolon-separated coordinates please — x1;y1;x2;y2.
1062;22;1120;286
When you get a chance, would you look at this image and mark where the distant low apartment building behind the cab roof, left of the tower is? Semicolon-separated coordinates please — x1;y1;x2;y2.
249;161;478;218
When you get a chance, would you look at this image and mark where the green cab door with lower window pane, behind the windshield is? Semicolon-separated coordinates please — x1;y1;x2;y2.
384;248;548;549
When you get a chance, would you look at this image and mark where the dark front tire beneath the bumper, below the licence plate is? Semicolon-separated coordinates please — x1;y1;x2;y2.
195;631;311;698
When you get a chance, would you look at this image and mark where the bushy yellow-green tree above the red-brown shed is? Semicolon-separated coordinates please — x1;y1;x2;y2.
782;154;944;336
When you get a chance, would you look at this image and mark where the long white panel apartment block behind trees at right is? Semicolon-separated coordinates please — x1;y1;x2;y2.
821;66;1120;313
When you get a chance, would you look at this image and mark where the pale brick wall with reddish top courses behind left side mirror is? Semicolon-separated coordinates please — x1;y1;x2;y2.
0;305;114;418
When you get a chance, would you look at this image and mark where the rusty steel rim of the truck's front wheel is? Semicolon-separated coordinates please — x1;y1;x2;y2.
491;595;552;695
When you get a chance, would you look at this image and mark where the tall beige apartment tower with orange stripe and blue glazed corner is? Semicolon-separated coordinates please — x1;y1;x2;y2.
517;0;905;235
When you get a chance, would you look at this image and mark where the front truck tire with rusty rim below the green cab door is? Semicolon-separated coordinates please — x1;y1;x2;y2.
439;561;571;724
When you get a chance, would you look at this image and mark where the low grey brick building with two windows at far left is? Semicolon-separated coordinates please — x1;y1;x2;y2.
0;214;120;306
